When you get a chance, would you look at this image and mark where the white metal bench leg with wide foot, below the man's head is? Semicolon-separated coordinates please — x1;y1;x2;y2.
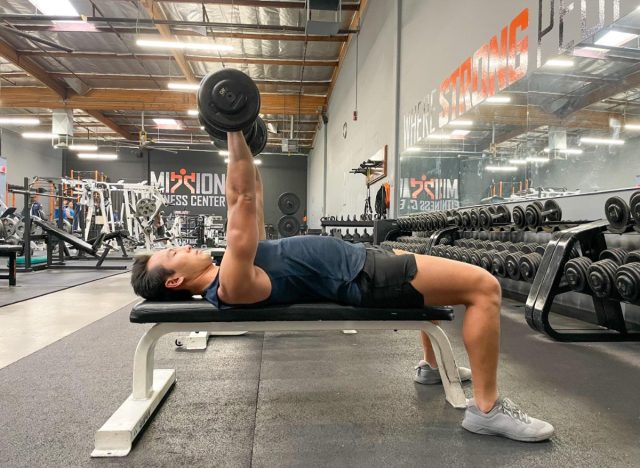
91;324;176;457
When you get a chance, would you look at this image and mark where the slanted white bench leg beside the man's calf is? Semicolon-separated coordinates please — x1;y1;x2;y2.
423;323;467;408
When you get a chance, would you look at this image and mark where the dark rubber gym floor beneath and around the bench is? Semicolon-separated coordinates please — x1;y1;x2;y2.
0;276;640;468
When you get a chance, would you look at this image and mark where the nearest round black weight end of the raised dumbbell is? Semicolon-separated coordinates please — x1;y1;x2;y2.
198;68;260;132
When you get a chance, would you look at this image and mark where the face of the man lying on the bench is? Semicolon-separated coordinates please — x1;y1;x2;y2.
147;245;212;288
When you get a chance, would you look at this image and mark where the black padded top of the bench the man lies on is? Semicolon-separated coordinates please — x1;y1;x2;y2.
129;299;453;323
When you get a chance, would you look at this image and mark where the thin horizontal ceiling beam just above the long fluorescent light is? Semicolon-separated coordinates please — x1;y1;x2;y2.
12;24;349;42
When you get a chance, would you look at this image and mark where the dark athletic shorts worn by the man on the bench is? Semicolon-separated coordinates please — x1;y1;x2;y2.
356;245;424;308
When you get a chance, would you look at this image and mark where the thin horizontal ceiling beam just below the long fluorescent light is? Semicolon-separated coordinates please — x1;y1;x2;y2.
18;50;339;67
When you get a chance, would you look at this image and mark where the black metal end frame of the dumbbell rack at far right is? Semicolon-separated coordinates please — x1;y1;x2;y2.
525;220;640;342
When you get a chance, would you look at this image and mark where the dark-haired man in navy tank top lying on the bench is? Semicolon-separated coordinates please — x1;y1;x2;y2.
131;132;553;442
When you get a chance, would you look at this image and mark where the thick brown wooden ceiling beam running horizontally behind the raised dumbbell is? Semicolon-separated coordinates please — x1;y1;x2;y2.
0;86;326;115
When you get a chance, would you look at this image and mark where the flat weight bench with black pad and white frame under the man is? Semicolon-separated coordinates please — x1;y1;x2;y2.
91;299;467;457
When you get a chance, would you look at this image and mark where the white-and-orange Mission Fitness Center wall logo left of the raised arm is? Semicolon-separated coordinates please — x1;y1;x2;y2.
149;167;226;214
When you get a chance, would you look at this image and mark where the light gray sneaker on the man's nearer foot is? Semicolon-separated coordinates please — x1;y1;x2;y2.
462;398;553;442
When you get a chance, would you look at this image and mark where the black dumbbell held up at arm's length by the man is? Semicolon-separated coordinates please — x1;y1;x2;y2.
197;68;267;156
